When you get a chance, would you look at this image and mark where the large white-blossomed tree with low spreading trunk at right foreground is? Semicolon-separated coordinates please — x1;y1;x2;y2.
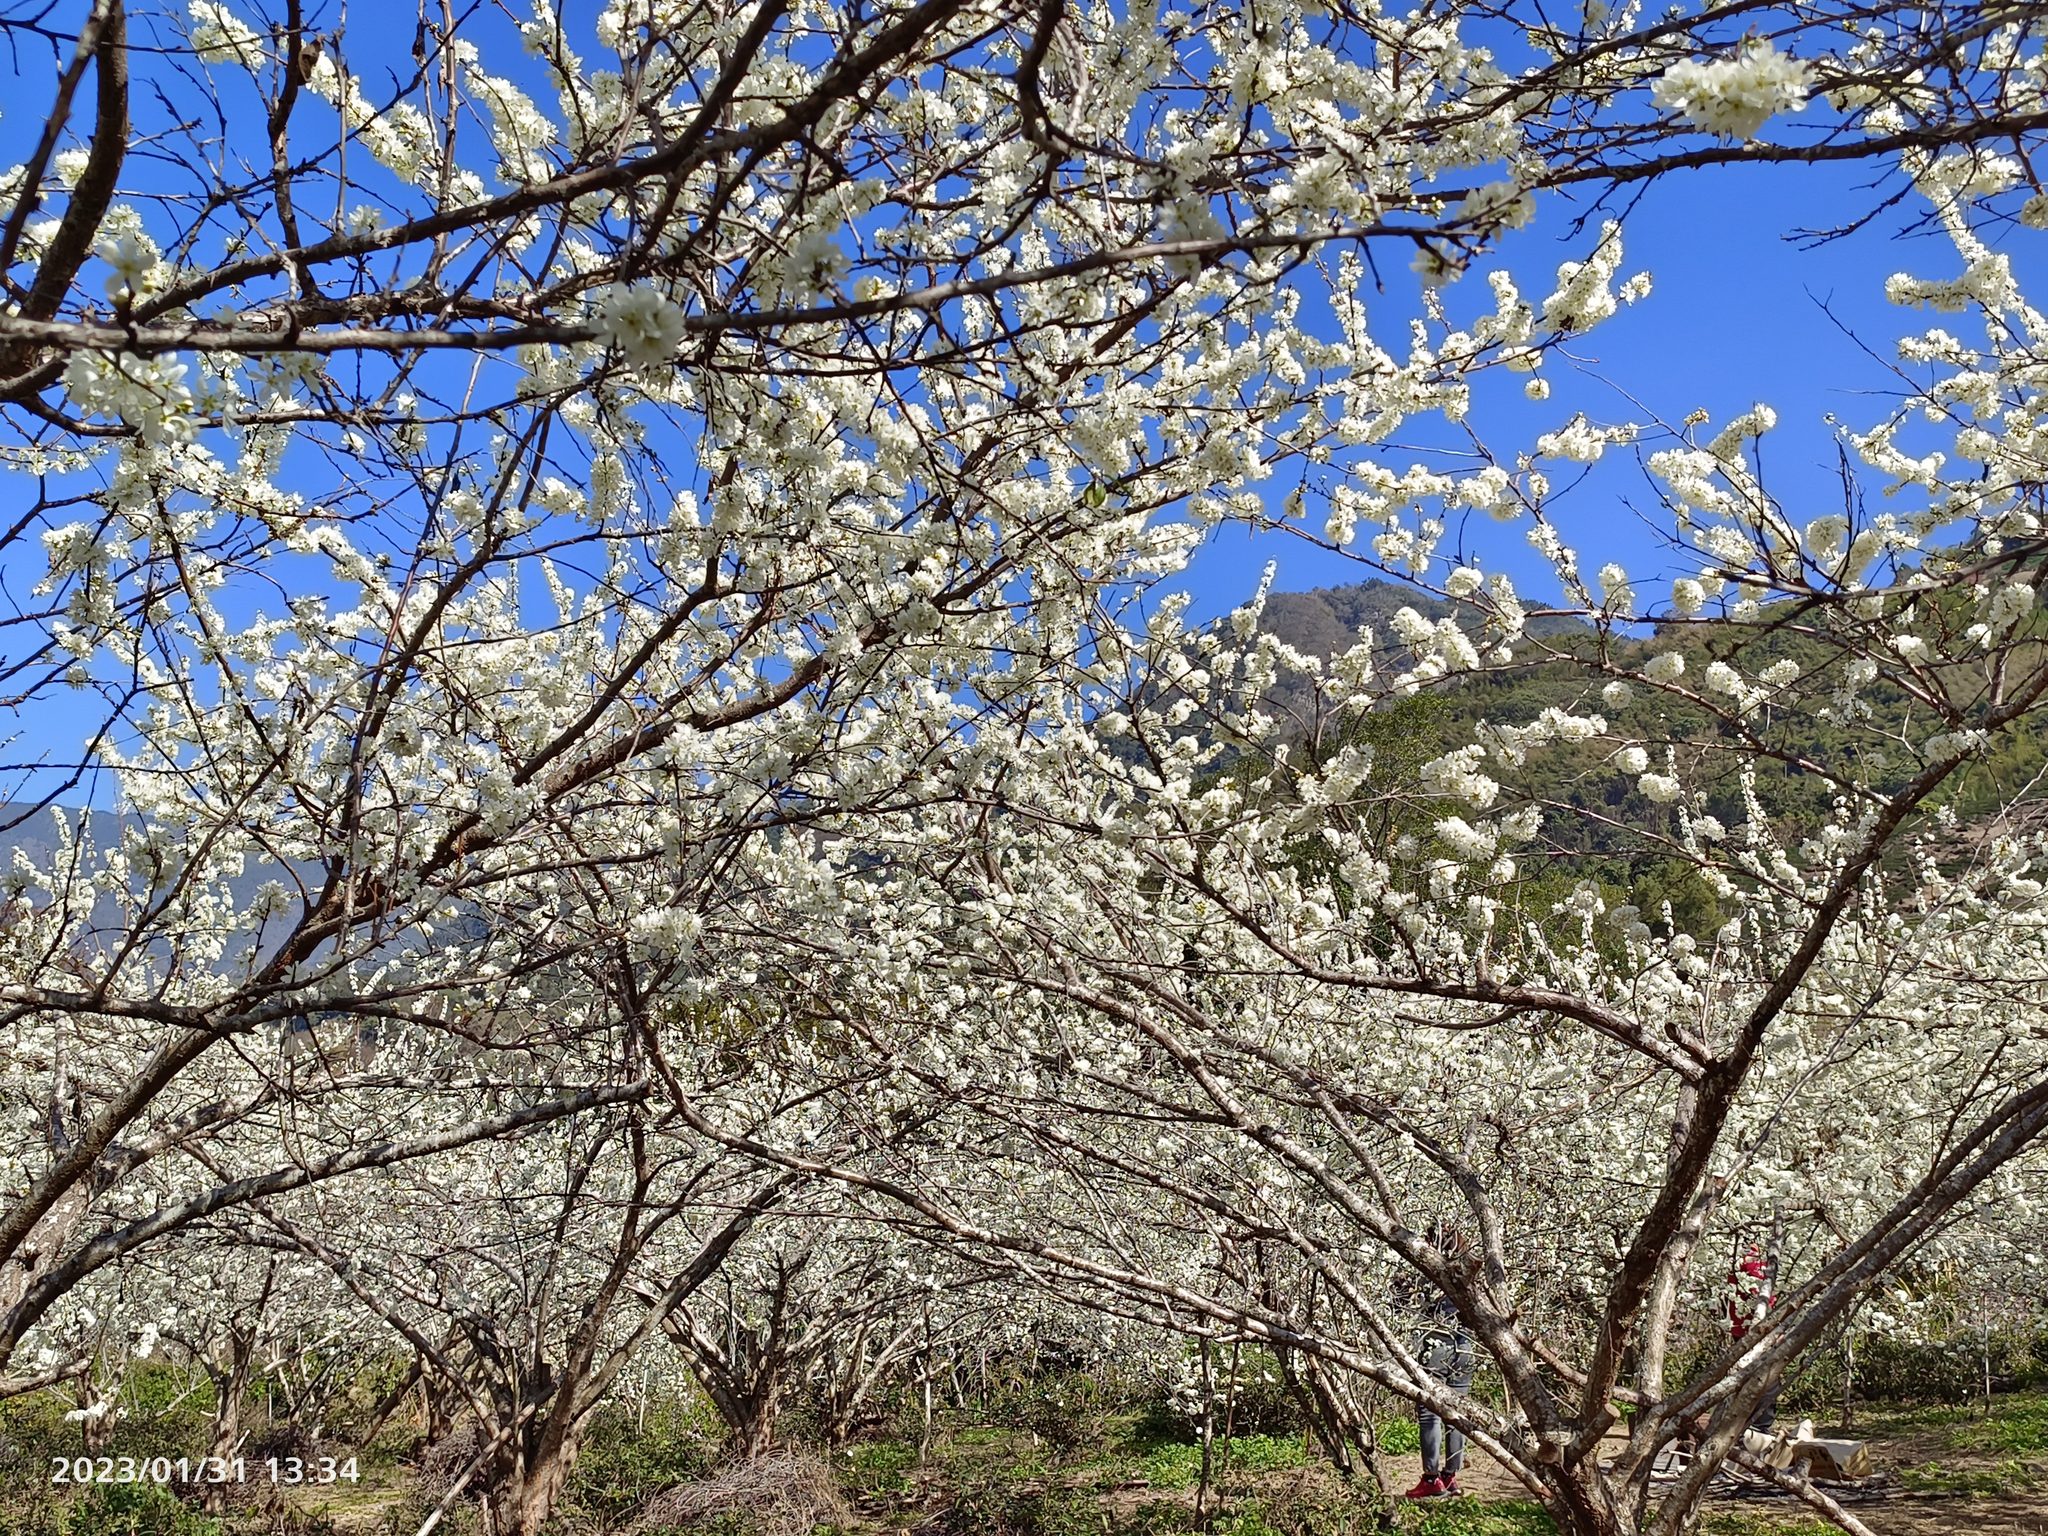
647;147;2048;1532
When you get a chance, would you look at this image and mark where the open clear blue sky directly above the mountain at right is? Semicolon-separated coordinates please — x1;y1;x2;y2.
1180;151;2048;618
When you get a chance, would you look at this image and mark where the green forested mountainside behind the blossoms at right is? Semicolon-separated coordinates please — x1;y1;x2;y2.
1262;580;2048;934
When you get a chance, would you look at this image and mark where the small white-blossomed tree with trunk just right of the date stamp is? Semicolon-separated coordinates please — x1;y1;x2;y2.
250;1081;795;1536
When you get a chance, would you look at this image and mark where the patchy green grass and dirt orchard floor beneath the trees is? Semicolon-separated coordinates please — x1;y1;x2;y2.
0;1393;2048;1536
